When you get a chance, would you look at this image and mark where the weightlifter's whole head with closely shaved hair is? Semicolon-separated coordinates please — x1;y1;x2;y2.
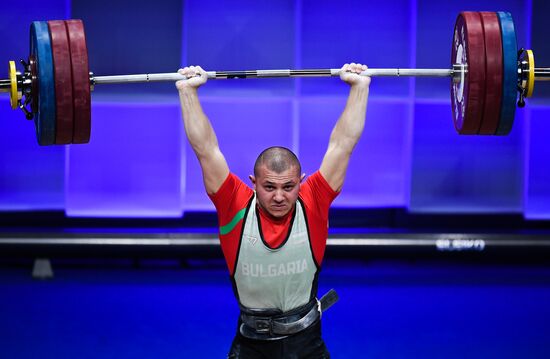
250;146;304;218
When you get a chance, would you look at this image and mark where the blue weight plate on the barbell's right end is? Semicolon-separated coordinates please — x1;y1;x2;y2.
496;11;518;135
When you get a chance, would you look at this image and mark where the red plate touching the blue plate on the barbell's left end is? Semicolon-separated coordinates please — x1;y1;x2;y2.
48;20;73;145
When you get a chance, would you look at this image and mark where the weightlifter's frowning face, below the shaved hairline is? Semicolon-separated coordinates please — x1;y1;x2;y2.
250;165;304;218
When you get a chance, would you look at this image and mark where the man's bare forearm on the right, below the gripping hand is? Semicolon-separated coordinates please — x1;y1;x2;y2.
329;85;369;153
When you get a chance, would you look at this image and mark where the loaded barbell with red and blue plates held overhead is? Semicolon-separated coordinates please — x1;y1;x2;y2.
0;11;550;145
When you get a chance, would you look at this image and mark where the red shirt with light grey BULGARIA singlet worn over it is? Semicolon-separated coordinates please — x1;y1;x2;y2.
210;172;338;311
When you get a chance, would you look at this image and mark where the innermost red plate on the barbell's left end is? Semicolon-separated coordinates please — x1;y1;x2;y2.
65;20;92;143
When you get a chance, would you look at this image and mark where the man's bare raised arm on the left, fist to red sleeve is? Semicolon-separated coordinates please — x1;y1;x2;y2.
176;66;229;194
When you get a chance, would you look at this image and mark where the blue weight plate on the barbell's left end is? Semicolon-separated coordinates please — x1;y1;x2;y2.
30;21;55;146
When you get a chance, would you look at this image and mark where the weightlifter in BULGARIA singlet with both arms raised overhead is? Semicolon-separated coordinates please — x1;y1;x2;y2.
176;63;370;358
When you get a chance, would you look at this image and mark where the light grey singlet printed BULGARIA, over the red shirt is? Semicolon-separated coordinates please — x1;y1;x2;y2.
232;195;319;312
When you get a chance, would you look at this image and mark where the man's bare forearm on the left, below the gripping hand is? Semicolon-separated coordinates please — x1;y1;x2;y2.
179;88;218;159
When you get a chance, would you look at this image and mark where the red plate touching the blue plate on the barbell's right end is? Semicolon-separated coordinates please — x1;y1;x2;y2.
479;12;503;135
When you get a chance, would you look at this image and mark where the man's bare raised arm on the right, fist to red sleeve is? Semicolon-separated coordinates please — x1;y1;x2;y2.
320;63;370;191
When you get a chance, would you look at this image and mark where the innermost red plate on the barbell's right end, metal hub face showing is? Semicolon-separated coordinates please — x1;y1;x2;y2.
451;12;485;134
